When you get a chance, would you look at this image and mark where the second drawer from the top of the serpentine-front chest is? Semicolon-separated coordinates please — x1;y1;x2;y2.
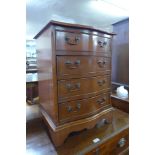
57;56;111;79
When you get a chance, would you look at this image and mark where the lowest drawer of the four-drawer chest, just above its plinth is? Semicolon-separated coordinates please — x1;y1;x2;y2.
59;92;110;122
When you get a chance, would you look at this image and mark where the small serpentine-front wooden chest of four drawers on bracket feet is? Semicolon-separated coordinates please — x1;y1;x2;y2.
35;21;113;146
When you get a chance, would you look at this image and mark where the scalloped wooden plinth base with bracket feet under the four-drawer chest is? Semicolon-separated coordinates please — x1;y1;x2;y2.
42;108;114;146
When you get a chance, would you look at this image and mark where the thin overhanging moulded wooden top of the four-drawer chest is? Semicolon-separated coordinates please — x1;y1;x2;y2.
34;20;115;39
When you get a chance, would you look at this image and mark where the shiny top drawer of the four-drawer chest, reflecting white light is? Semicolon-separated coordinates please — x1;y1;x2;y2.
56;31;111;53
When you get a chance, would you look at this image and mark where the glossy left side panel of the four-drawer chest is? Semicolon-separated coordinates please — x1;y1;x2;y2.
36;25;58;124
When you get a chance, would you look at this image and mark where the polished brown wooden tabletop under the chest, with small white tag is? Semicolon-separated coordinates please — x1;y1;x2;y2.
54;109;129;155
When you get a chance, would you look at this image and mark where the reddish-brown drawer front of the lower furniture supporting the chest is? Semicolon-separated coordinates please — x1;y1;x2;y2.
86;129;129;155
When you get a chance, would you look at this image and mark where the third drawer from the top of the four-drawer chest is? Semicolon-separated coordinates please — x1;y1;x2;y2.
58;75;110;102
